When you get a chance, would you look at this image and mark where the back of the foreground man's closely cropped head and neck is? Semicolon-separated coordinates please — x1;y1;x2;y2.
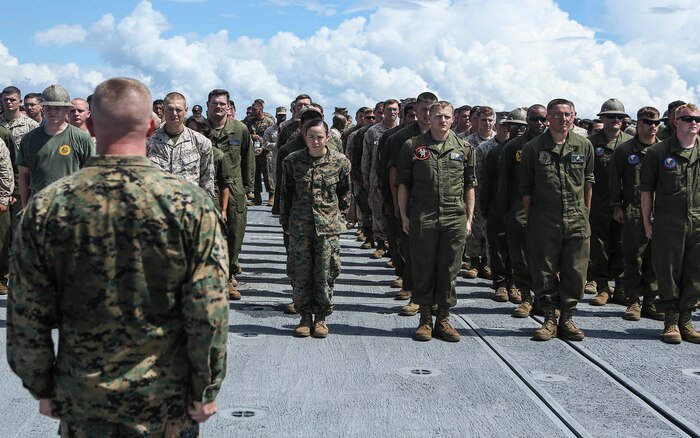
90;78;152;154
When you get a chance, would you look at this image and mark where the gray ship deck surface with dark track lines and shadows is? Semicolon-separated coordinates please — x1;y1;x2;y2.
0;207;700;438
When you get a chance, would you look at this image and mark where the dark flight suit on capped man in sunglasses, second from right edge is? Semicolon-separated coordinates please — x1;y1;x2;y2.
610;137;659;303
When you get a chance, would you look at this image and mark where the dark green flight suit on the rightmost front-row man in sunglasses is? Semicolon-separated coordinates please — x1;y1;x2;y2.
639;137;700;312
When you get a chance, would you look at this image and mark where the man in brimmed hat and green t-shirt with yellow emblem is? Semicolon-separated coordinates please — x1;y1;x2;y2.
17;85;95;206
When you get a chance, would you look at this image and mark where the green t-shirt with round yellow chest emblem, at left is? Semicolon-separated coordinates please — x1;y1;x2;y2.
17;125;95;193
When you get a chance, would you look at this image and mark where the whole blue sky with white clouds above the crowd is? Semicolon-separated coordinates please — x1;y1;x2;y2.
0;0;700;118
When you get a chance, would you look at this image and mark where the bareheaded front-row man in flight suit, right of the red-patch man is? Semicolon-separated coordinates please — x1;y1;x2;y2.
520;99;594;341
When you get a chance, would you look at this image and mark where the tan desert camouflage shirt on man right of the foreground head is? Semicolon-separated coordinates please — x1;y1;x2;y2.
146;126;214;196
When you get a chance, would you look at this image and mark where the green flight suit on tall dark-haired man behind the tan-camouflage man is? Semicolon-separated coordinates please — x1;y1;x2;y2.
209;120;255;275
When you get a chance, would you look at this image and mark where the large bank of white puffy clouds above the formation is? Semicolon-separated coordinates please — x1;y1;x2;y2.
5;0;700;116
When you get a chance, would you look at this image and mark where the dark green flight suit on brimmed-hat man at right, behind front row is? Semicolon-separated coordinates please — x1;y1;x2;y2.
588;130;632;283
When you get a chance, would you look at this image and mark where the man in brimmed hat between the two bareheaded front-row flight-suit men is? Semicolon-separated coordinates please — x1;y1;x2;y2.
476;108;527;304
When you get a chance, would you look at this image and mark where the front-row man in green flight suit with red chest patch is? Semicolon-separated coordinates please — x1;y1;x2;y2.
396;101;476;342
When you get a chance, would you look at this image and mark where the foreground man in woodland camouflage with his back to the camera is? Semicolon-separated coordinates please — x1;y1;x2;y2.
7;78;228;437
